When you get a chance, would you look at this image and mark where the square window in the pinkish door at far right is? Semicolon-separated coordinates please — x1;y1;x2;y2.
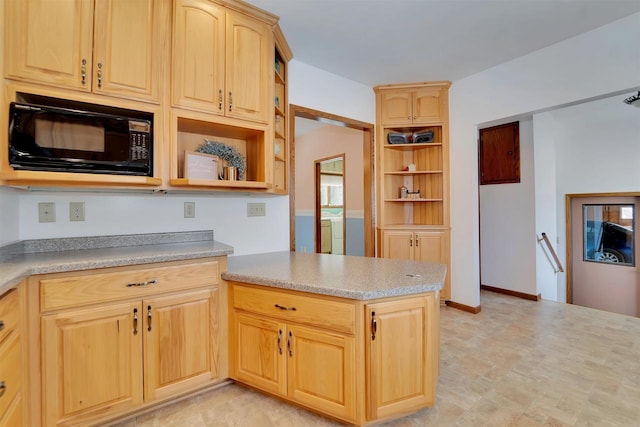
582;205;635;265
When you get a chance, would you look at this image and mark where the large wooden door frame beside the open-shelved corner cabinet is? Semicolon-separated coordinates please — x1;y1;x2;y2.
289;104;376;257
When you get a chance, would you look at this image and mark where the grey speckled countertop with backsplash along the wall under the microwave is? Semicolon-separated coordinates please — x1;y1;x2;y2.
0;231;233;294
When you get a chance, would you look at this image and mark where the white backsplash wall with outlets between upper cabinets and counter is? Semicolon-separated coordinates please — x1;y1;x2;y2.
20;191;289;255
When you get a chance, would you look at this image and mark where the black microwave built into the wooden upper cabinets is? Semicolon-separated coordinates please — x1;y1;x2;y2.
9;94;153;176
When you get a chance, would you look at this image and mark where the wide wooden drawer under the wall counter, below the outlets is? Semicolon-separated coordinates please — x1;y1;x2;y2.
40;261;219;311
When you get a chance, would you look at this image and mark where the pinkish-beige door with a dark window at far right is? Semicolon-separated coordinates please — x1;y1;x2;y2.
567;195;640;317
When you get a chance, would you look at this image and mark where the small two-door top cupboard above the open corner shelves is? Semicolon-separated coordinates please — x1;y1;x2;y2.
380;87;443;125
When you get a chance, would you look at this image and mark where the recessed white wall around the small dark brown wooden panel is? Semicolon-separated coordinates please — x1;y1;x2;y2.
479;119;537;295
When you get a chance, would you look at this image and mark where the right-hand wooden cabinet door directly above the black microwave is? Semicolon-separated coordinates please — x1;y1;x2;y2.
93;0;164;102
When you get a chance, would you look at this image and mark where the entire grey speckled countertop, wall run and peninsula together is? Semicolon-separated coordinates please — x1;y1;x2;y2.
0;231;446;300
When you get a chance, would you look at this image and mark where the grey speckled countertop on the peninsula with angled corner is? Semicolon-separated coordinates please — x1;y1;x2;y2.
222;252;447;300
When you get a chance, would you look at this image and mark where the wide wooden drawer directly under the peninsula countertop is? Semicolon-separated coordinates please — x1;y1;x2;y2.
233;285;355;334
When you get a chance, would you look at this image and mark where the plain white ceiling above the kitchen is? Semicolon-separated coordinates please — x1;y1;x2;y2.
247;0;640;86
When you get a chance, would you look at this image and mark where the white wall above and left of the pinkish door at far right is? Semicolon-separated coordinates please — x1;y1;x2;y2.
546;96;640;301
